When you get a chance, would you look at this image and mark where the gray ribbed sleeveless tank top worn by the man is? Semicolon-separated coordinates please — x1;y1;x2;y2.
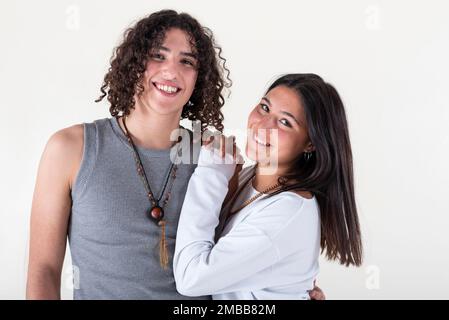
68;118;210;299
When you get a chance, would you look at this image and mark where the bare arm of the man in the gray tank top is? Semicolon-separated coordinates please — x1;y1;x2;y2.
26;125;84;299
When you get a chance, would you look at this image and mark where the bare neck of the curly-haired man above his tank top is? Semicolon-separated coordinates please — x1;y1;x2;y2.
120;104;181;150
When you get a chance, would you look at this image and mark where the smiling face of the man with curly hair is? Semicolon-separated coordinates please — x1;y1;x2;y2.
137;28;198;114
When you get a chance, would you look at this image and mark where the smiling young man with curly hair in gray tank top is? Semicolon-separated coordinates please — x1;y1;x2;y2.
27;10;228;299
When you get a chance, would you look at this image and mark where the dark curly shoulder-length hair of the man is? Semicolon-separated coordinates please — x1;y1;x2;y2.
95;10;232;132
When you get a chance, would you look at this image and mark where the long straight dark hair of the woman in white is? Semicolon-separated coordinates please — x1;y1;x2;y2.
267;74;362;266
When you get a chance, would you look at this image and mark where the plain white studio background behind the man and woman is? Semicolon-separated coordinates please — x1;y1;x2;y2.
0;0;449;299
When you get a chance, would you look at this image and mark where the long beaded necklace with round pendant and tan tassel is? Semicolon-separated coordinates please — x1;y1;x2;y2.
117;116;181;269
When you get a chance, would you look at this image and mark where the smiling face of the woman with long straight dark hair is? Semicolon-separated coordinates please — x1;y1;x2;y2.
246;85;313;171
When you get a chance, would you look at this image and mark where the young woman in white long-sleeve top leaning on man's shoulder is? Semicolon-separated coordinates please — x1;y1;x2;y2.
174;74;362;299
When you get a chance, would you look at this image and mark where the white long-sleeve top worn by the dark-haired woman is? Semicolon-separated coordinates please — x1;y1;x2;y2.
173;147;320;299
